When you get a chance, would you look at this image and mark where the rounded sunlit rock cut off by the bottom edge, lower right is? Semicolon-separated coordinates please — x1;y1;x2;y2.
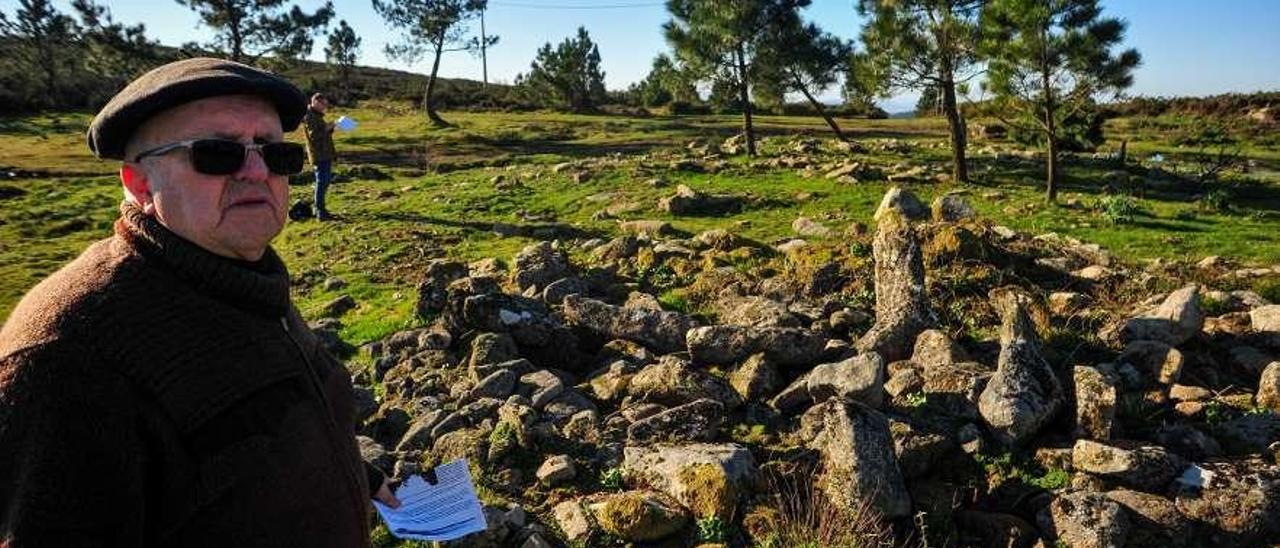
1037;492;1129;548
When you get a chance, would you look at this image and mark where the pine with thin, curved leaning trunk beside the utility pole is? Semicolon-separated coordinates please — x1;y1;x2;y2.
374;0;498;125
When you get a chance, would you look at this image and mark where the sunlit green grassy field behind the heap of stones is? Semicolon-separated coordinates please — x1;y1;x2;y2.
0;102;1280;344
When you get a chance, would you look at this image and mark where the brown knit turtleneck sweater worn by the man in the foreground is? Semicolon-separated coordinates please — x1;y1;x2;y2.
0;204;381;548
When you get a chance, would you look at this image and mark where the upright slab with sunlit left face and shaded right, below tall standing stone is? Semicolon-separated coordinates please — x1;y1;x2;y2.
800;398;911;519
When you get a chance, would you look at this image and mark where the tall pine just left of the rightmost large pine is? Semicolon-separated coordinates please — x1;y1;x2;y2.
858;0;984;182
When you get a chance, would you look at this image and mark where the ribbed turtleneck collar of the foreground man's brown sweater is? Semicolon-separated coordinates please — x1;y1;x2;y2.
115;200;289;318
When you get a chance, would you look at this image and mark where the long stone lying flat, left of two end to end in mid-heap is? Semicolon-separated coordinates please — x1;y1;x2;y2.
562;294;698;353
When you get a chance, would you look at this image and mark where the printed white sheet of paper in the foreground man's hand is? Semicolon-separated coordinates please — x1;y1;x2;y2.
374;458;488;540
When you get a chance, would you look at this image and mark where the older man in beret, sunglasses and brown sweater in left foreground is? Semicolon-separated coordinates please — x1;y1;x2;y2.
0;59;398;547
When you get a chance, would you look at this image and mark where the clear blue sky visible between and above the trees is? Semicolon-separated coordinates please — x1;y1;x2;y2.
0;0;1280;111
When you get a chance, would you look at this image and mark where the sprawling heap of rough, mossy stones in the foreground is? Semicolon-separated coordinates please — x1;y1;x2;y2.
314;181;1280;548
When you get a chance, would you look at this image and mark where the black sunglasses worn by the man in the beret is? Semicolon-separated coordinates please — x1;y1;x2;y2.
133;138;306;175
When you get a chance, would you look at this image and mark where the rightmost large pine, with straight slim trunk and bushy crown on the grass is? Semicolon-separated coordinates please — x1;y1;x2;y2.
982;0;1142;202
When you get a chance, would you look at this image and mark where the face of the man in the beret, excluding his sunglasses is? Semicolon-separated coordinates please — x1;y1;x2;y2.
122;95;289;261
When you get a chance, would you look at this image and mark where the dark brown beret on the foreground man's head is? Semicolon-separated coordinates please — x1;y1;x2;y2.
87;58;307;160
